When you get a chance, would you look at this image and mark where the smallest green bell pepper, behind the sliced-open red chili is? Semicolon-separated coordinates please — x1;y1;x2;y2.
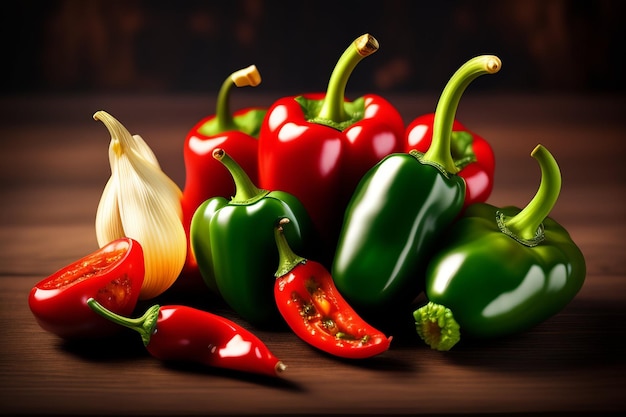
191;148;315;327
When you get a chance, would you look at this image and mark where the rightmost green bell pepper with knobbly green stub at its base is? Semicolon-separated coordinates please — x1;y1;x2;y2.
413;145;586;351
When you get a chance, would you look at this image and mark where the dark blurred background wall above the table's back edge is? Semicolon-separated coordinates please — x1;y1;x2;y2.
1;0;626;95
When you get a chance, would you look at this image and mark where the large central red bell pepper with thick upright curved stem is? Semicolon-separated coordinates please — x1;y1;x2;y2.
259;34;405;256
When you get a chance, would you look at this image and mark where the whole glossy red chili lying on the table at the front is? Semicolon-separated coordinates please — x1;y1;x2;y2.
87;299;287;376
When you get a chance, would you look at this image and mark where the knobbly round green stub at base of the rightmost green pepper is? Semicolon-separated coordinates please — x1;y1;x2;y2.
413;301;461;351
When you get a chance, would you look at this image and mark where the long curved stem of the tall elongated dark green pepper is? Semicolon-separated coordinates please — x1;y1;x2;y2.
423;55;502;174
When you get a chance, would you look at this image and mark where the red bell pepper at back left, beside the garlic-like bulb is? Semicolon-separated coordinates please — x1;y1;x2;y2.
181;65;267;274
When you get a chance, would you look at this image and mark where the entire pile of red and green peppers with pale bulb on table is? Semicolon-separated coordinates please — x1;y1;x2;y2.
29;34;586;376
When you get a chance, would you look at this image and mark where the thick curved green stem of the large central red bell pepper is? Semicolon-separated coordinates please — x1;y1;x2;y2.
317;33;378;122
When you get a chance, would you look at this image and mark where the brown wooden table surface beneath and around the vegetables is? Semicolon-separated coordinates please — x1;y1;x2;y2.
0;90;626;415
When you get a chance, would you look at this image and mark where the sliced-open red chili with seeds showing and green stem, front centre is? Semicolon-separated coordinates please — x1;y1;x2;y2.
274;218;391;359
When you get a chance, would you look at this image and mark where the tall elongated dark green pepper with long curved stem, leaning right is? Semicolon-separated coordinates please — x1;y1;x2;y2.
332;55;501;328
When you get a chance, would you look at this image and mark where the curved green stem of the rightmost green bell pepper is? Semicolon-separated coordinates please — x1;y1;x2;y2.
503;145;561;241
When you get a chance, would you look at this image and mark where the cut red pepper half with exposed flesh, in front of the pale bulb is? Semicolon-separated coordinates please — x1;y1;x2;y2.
28;238;144;339
